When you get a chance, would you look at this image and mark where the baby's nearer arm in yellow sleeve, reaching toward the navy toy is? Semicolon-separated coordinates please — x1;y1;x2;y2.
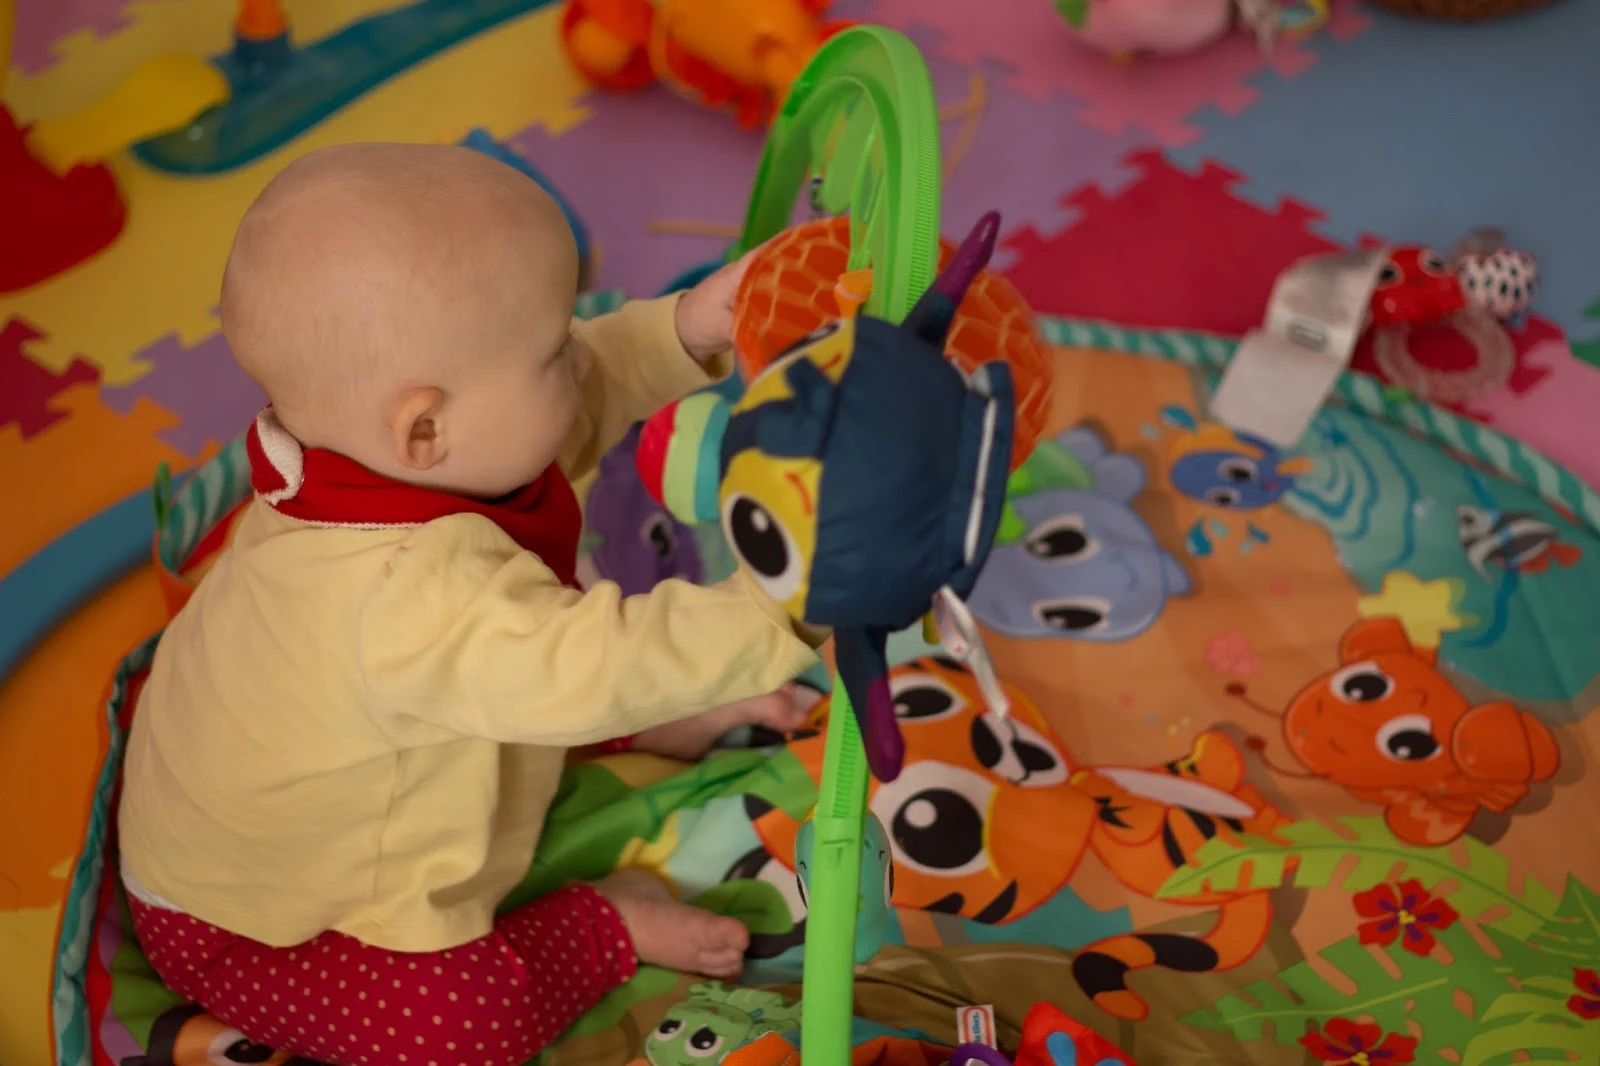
362;515;818;747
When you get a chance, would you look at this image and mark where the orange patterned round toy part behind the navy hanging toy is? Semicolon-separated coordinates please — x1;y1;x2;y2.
733;218;1054;471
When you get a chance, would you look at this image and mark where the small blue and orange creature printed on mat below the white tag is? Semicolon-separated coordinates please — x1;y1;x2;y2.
1168;423;1312;511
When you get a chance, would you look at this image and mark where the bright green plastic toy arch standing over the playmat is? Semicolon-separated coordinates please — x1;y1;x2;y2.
736;26;941;1066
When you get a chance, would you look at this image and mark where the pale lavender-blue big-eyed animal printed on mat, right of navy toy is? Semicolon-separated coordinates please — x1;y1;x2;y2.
968;426;1194;642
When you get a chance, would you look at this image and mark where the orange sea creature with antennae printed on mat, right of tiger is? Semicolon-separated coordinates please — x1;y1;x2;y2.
1229;618;1562;847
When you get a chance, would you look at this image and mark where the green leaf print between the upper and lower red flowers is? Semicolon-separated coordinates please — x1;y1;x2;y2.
1182;924;1514;1050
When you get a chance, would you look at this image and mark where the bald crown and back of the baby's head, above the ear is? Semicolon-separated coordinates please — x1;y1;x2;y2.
221;144;578;499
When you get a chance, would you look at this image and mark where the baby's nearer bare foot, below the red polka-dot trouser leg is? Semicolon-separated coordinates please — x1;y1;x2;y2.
595;869;750;978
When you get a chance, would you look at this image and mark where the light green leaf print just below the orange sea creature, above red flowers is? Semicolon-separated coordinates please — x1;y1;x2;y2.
1157;818;1557;938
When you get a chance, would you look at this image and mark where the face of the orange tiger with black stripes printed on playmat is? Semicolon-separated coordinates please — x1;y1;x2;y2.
746;656;1094;924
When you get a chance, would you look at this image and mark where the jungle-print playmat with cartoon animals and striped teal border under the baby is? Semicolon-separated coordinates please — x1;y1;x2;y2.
56;312;1600;1066
